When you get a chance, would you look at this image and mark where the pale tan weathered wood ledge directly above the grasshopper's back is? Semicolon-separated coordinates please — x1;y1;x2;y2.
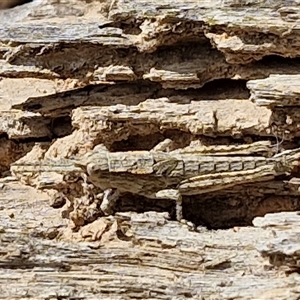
72;98;274;143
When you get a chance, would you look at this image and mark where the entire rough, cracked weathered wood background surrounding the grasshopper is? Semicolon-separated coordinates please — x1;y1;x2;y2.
0;0;300;300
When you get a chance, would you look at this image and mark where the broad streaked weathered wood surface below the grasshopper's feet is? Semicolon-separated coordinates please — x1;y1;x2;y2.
0;182;298;300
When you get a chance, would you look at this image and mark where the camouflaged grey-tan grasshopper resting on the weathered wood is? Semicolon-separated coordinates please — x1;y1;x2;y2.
69;142;300;221
